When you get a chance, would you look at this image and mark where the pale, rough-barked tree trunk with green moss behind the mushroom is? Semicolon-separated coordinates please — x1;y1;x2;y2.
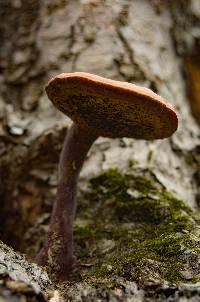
0;0;200;301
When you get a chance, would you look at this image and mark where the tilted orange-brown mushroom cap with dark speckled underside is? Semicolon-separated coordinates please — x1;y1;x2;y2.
46;72;178;140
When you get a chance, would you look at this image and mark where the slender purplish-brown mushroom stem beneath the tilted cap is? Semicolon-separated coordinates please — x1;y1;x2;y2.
36;123;97;279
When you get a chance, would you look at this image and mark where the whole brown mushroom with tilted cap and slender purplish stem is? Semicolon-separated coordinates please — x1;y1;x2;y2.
37;72;178;280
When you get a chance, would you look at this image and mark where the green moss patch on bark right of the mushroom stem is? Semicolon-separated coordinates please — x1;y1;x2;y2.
75;169;200;286
